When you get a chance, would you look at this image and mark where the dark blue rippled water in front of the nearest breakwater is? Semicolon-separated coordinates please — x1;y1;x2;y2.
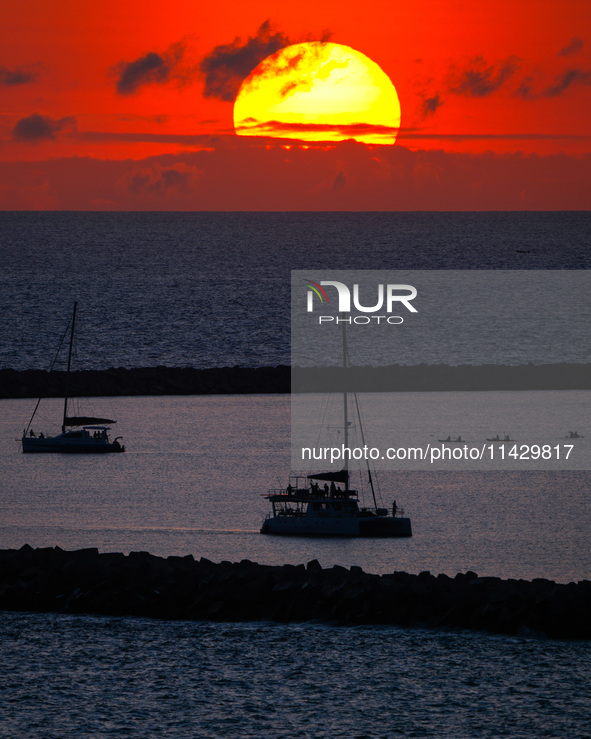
0;613;591;739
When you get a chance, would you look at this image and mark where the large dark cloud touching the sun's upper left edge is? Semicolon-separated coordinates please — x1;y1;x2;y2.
201;20;294;102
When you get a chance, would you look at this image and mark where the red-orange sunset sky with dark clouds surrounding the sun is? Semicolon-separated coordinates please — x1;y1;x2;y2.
0;0;591;210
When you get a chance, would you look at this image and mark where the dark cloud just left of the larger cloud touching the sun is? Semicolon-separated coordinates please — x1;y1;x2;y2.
114;43;192;95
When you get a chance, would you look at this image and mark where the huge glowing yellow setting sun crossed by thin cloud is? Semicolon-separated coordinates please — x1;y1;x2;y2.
234;42;400;144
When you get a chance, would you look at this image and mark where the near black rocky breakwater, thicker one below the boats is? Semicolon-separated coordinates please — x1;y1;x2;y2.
0;545;591;639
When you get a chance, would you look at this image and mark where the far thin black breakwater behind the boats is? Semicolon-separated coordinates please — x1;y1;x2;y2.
0;364;591;399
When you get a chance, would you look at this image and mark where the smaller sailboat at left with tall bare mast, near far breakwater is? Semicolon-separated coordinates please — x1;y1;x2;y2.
21;302;125;454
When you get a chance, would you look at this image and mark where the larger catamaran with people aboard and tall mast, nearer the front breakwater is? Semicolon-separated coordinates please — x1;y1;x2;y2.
261;323;412;538
